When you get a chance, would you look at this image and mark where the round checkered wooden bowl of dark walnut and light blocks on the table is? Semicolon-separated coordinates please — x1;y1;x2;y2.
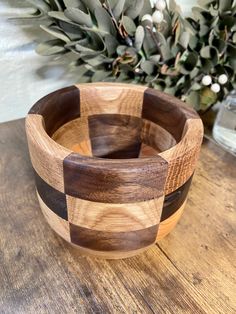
26;83;203;258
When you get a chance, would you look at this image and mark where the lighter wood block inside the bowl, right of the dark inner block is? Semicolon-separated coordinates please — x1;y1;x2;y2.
141;119;176;152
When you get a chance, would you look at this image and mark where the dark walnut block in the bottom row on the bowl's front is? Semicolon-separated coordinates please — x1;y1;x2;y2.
70;223;158;252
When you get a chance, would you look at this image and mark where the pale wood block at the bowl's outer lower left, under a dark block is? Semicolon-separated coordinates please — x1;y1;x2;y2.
36;191;71;242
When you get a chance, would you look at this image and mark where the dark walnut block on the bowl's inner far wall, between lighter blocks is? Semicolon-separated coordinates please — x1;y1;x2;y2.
88;114;142;159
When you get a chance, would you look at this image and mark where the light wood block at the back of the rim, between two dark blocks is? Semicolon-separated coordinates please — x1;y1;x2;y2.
76;83;146;117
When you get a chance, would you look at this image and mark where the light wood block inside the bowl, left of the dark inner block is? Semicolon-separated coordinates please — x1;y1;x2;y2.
52;117;92;156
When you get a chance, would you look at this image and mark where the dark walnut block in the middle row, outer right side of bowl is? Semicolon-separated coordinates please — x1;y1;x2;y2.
161;175;193;221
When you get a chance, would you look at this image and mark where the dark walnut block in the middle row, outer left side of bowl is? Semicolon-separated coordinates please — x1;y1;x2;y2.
34;171;68;220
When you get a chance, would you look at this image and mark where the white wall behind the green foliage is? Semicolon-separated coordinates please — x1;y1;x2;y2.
0;0;196;122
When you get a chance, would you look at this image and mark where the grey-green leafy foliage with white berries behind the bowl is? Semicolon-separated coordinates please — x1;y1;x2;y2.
18;0;236;112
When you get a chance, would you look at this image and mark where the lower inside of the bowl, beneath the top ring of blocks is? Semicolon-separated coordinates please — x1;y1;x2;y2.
52;113;176;159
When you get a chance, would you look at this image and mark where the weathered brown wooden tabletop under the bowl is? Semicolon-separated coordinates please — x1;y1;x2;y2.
0;120;236;314
